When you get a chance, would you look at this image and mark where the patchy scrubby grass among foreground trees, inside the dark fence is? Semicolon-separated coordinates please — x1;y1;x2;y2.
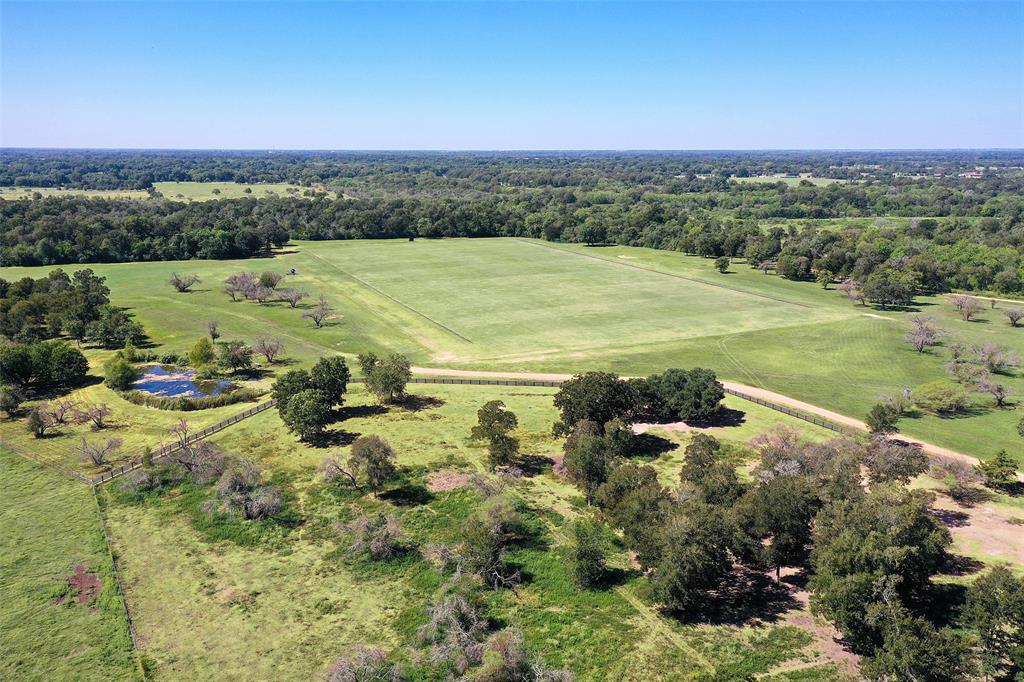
97;385;838;680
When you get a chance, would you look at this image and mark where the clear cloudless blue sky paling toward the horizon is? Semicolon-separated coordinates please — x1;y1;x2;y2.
0;0;1024;150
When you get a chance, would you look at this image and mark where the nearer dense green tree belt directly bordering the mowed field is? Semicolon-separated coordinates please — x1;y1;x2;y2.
0;187;1024;293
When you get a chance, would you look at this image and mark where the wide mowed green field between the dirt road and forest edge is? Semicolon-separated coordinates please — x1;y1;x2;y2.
4;239;1024;462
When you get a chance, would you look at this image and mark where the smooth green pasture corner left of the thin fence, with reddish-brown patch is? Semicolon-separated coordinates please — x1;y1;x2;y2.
0;446;138;682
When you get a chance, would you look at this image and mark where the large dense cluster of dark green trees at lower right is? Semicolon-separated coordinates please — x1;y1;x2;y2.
556;368;1024;682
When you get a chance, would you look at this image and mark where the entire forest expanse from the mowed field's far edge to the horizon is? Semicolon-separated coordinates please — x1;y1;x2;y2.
0;151;1024;293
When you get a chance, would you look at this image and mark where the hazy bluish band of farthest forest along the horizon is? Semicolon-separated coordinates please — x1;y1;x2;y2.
6;148;1024;191
